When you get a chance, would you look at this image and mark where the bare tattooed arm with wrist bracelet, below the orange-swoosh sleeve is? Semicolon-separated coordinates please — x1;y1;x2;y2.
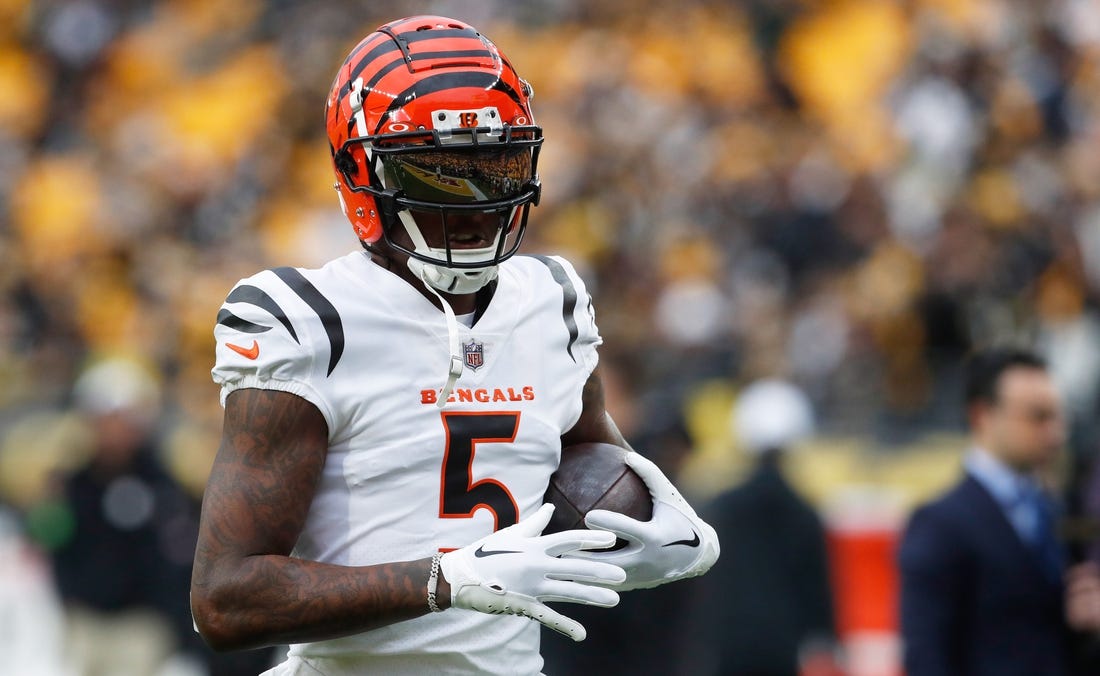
191;389;451;650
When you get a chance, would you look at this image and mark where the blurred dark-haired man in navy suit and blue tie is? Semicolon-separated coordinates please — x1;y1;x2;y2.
899;348;1070;676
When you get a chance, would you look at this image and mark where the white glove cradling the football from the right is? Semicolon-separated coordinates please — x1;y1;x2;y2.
569;453;719;591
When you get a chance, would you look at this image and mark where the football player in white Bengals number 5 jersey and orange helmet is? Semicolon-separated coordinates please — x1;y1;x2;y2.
191;16;718;676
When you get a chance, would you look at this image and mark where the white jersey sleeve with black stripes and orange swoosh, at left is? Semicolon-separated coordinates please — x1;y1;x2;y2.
210;273;333;430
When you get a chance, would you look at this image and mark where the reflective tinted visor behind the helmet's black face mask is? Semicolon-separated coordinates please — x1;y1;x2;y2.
381;147;531;204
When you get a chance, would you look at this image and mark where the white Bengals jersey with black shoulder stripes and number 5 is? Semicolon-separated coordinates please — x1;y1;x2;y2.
206;252;601;675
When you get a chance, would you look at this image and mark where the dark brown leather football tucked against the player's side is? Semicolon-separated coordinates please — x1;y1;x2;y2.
543;443;653;548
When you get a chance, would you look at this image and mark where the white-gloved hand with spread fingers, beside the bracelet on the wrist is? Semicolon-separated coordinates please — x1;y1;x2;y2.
439;505;626;641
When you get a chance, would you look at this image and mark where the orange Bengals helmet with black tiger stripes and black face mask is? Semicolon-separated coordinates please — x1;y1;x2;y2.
325;16;542;292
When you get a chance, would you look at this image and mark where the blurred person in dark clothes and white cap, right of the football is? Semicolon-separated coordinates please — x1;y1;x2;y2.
674;379;839;676
